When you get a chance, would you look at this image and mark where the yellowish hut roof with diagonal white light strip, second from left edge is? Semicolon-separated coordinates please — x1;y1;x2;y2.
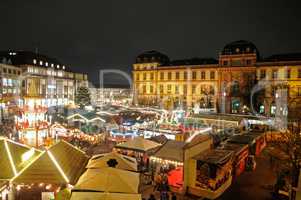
12;141;88;185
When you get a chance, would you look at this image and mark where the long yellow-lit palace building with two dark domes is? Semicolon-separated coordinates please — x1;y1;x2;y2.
133;40;301;116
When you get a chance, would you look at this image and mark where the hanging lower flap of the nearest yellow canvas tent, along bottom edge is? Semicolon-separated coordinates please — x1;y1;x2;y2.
70;192;141;200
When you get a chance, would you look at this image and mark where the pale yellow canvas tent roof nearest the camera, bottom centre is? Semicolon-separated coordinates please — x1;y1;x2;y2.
71;167;141;200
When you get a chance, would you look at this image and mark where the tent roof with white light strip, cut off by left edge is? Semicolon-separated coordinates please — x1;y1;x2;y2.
0;137;41;180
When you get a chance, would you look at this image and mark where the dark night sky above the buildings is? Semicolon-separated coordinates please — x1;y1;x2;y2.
0;0;301;86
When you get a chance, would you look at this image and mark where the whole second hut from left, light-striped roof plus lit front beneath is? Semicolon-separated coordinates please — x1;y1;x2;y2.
12;141;88;200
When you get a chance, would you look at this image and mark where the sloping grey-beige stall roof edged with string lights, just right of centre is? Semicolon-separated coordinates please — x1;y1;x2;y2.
154;140;185;162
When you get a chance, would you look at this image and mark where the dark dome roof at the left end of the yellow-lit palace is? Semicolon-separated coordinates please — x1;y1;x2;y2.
136;50;169;64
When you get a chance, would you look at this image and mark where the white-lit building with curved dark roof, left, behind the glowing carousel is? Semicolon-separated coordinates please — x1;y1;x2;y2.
0;51;88;107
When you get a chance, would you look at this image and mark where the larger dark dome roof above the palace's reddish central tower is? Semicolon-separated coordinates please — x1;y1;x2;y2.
222;40;259;56
